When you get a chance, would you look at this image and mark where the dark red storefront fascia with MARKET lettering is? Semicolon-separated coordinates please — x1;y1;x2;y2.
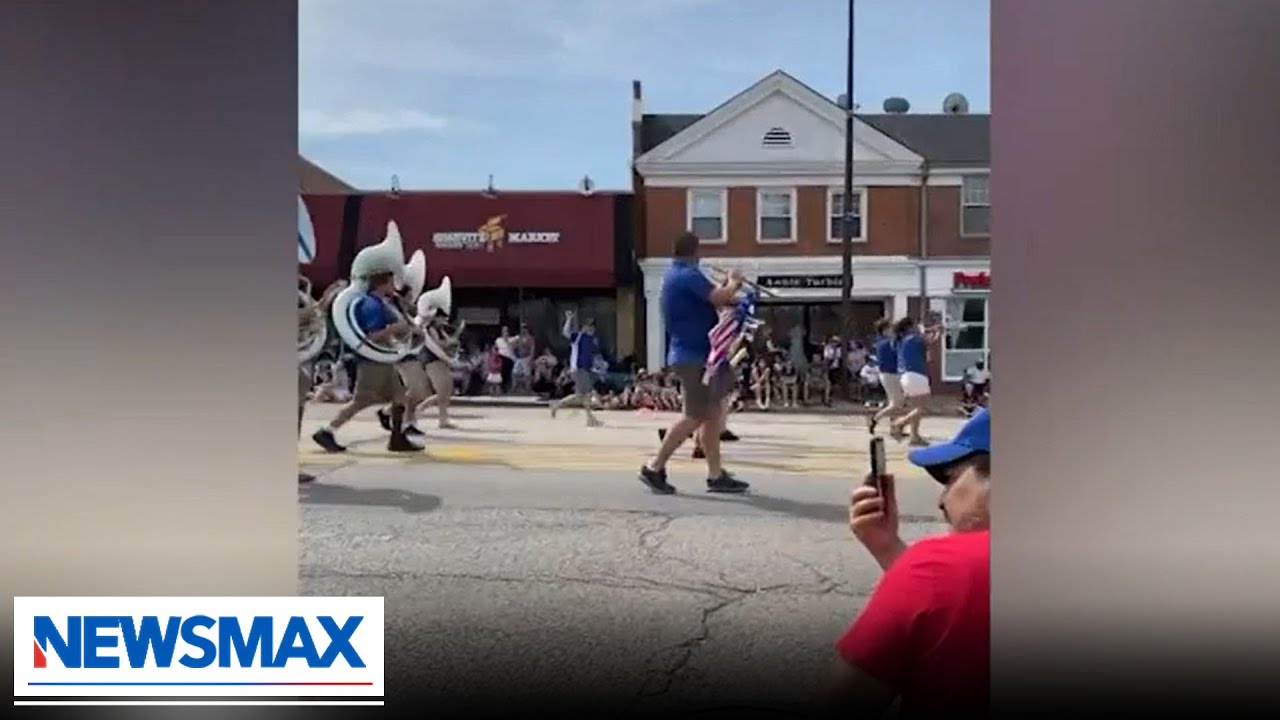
355;192;616;288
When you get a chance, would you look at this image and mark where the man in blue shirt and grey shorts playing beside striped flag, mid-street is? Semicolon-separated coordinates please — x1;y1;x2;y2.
640;233;749;495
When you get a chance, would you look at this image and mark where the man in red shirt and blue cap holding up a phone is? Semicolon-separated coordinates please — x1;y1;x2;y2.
822;410;991;717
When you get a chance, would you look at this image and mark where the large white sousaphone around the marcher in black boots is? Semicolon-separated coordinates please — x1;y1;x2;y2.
330;220;411;364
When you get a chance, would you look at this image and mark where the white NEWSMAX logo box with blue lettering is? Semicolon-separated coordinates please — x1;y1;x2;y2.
13;597;384;700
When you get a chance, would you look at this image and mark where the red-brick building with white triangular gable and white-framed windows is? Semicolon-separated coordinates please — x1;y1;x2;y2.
632;70;991;382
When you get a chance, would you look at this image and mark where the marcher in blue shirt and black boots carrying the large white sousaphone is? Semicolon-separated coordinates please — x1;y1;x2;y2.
311;273;422;452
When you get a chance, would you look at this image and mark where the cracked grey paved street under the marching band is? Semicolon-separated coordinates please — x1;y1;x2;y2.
298;406;959;715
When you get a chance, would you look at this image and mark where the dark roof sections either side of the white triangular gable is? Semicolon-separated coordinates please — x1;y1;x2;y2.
640;114;991;168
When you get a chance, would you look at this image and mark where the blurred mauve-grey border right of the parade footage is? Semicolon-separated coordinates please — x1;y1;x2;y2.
992;0;1280;712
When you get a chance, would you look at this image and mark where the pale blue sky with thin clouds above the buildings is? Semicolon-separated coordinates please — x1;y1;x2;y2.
298;0;991;190
